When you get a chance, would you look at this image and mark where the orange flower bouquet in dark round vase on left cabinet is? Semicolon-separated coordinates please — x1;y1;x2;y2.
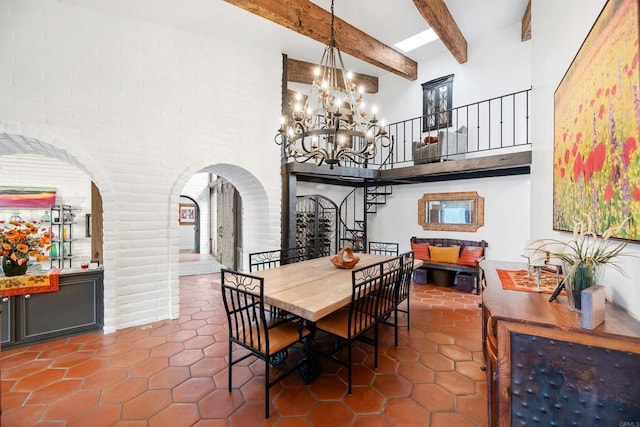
0;221;51;276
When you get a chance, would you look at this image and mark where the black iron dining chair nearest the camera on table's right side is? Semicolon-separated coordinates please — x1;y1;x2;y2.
316;263;382;394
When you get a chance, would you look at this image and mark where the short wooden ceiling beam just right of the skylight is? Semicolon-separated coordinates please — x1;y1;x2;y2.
413;0;467;64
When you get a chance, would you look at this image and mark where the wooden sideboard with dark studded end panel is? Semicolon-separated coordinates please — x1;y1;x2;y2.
480;261;640;426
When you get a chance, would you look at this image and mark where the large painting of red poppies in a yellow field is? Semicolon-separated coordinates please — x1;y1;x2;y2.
553;0;640;240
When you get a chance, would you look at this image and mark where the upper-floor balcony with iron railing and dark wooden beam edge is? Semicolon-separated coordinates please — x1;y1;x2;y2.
283;89;531;185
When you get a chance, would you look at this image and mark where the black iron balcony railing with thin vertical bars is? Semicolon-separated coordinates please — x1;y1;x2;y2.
362;89;531;169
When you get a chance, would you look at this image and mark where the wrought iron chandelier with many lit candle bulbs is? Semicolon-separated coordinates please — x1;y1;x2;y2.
275;0;390;169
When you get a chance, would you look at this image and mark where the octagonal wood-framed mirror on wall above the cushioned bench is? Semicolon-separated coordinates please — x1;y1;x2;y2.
418;191;484;231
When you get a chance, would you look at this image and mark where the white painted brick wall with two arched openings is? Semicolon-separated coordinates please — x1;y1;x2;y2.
0;0;281;332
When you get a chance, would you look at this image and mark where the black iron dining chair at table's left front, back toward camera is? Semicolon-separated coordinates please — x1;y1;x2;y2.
221;269;309;418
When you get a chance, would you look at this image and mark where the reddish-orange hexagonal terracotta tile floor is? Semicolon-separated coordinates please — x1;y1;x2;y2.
0;274;487;427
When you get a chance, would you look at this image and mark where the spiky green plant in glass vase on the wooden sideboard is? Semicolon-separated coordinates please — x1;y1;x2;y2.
530;214;633;312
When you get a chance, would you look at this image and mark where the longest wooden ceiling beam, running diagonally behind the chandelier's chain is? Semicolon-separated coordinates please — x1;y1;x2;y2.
225;0;418;80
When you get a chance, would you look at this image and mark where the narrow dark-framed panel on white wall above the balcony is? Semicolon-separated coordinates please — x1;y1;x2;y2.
422;74;453;132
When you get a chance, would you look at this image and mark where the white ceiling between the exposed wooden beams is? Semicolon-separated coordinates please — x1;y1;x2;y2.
63;0;527;76
